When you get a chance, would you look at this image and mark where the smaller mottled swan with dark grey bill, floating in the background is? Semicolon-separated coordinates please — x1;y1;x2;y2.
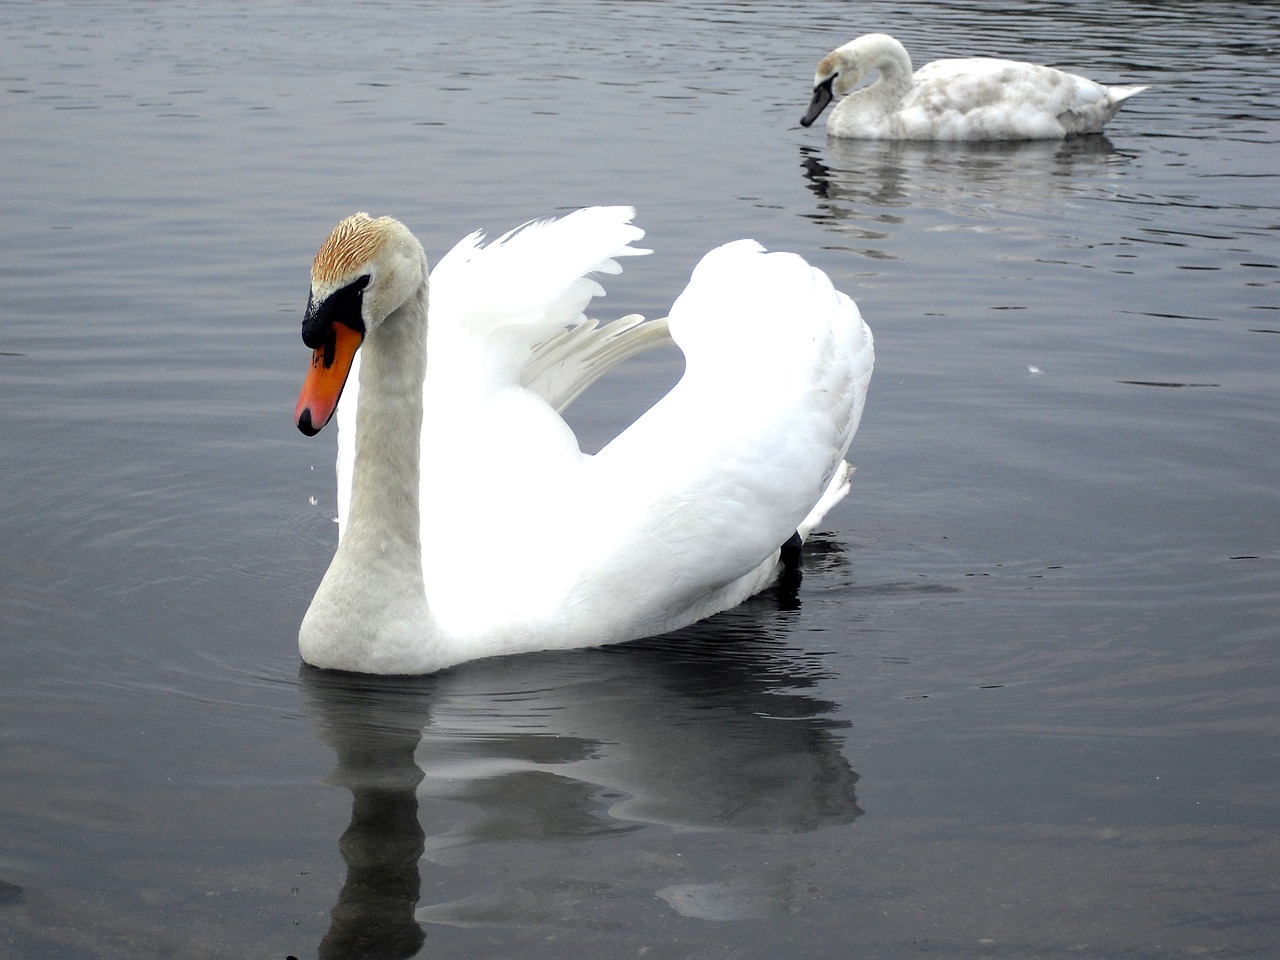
800;33;1147;140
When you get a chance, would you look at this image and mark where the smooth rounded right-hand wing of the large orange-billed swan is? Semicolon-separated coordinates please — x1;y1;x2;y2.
568;241;874;635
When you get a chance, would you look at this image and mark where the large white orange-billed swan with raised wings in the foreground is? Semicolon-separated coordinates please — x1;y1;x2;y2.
296;207;873;673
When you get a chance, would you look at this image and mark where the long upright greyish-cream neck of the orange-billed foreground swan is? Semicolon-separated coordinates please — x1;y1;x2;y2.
300;273;433;673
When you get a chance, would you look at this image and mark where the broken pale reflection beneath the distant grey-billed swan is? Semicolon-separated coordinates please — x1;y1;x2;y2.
800;136;1130;259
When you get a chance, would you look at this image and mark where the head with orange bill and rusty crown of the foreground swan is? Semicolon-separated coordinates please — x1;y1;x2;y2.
294;214;426;436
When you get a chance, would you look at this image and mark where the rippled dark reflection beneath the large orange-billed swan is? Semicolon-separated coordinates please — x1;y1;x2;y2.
301;583;860;959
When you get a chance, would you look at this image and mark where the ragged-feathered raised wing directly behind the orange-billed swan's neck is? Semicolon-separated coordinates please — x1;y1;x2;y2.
422;207;666;491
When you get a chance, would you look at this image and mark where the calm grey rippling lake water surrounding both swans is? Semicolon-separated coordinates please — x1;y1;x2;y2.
0;0;1280;960
